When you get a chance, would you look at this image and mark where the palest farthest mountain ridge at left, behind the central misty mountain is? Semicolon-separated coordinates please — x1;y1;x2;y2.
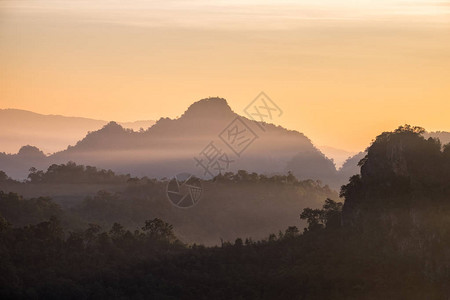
0;109;155;153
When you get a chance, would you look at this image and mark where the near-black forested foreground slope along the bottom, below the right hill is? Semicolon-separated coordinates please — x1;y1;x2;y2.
0;216;445;299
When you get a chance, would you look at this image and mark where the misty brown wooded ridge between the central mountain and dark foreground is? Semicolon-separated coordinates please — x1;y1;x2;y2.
0;163;338;245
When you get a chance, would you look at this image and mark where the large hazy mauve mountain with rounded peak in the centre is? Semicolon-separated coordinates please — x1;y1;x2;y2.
0;98;337;183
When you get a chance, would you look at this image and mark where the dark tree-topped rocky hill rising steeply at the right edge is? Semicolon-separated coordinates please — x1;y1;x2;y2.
341;127;450;279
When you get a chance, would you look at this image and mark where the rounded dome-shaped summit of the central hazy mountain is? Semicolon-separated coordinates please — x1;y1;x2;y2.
182;97;234;118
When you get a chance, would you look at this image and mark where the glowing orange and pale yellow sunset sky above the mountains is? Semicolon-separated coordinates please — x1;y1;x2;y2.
0;0;450;151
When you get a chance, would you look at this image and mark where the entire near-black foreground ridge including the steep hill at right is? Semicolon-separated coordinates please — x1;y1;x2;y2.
0;126;450;299
